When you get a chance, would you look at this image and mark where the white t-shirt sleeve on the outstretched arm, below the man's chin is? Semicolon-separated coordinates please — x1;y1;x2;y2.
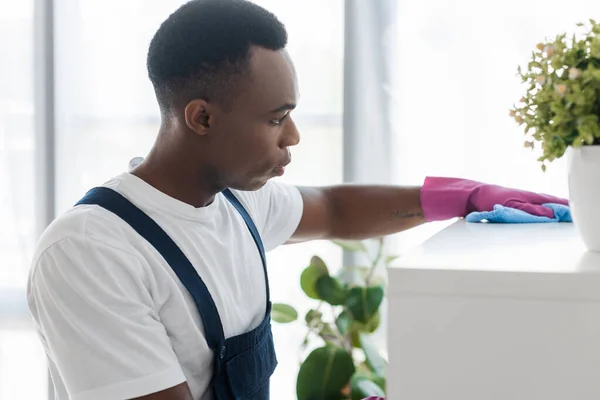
234;180;304;251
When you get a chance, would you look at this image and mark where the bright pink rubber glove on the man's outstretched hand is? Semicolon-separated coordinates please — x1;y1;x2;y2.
421;177;569;221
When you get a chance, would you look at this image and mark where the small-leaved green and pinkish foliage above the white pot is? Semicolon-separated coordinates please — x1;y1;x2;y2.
510;20;600;169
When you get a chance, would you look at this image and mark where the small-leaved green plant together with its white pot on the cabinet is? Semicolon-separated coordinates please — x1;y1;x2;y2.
510;20;600;251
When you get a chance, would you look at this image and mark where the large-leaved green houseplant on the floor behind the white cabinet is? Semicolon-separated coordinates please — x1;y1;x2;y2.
273;239;395;400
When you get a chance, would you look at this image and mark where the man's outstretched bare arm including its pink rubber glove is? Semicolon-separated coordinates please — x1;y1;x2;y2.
290;177;568;243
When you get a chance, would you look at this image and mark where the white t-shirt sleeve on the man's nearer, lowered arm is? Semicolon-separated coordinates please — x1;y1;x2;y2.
28;238;186;400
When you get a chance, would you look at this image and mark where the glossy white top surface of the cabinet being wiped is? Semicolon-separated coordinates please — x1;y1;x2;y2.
391;220;600;273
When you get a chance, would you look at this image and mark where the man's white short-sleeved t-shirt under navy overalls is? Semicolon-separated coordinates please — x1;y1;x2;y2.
28;173;303;400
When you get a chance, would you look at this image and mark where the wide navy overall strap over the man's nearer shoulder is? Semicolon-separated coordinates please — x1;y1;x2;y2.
76;187;225;349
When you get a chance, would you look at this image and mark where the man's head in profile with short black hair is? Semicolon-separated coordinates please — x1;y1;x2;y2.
147;0;299;190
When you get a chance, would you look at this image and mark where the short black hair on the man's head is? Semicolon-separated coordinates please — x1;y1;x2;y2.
147;0;287;112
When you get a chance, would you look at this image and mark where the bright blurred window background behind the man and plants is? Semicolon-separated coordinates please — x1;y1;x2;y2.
0;0;600;400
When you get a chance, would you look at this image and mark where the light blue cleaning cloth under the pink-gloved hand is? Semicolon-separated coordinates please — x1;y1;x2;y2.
465;203;573;224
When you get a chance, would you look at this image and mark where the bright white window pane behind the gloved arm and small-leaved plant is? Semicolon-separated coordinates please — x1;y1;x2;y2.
393;0;600;249
